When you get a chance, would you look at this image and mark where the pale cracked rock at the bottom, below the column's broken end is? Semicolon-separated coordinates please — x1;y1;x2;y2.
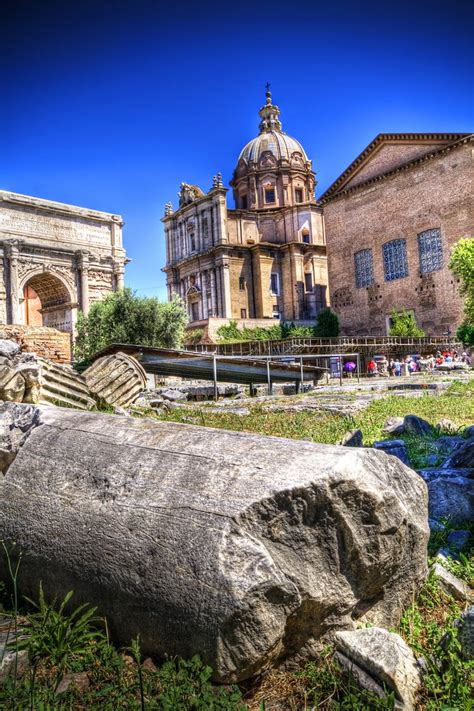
335;627;421;711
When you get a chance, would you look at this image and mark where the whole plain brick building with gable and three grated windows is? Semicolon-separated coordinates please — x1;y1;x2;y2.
318;133;474;336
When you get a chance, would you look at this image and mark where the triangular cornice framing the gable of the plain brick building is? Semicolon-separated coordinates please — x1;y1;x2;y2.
317;133;474;207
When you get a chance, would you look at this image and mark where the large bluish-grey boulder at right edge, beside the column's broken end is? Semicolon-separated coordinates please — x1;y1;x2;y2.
428;477;474;526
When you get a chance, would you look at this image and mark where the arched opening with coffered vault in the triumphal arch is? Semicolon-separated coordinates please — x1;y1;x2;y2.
23;272;73;332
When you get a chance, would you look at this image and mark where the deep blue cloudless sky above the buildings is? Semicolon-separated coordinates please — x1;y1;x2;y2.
0;0;474;298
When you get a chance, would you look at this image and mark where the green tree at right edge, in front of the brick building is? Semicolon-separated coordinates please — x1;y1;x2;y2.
449;237;474;345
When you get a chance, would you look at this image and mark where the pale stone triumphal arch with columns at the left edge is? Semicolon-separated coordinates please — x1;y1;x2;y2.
0;190;127;332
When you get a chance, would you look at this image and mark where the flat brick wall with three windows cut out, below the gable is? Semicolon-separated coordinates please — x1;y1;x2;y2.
324;143;474;336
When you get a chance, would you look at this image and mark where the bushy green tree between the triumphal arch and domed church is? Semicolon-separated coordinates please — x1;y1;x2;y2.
75;289;188;360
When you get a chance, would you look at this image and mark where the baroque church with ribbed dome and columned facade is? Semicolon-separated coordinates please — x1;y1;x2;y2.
163;88;327;326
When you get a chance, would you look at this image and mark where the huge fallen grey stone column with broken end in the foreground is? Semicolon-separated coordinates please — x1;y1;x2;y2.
0;408;428;682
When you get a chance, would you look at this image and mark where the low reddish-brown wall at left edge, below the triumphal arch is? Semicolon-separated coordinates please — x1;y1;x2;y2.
0;324;72;364
